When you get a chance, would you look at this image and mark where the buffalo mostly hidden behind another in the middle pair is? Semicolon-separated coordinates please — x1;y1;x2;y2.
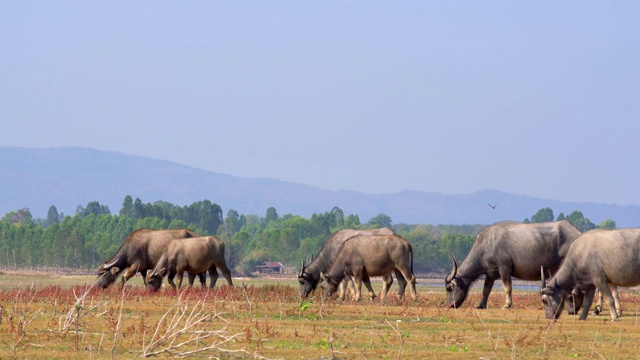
298;227;398;299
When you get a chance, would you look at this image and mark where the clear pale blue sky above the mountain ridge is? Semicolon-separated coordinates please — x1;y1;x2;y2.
0;0;640;205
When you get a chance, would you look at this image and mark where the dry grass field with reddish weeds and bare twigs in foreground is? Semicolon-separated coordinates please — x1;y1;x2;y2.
0;274;640;359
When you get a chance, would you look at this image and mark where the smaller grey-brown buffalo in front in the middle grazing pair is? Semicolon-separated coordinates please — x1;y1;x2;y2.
320;235;416;301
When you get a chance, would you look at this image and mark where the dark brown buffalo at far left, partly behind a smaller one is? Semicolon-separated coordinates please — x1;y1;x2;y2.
96;229;205;288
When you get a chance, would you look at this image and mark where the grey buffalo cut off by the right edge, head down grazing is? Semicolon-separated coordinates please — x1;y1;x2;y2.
540;229;640;321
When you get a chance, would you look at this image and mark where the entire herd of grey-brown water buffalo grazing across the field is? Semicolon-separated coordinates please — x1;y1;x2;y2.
96;221;640;321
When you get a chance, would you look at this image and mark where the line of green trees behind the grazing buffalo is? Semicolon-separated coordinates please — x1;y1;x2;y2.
0;195;615;275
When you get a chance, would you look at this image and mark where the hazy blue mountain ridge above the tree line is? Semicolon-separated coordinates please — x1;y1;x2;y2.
0;147;640;227
